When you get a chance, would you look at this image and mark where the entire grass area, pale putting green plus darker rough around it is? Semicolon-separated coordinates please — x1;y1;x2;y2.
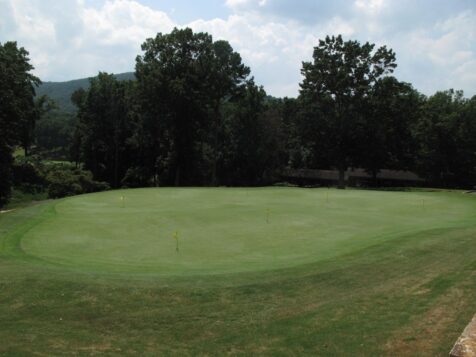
0;188;476;356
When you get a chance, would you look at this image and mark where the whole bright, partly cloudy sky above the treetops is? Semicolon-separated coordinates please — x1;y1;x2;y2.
0;0;476;97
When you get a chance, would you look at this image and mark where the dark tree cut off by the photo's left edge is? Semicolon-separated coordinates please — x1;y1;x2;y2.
0;42;40;206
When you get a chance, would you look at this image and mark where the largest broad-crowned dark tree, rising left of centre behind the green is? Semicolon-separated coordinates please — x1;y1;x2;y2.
136;28;250;185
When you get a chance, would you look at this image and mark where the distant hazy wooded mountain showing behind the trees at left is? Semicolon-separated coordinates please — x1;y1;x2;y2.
36;72;135;112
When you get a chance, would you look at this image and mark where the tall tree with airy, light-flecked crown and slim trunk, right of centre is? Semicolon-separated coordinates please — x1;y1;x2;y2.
300;35;396;188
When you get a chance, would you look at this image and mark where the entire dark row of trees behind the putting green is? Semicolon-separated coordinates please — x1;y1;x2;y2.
0;29;476;207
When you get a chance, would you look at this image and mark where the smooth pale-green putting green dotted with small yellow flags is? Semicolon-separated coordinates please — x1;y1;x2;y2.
16;188;476;275
